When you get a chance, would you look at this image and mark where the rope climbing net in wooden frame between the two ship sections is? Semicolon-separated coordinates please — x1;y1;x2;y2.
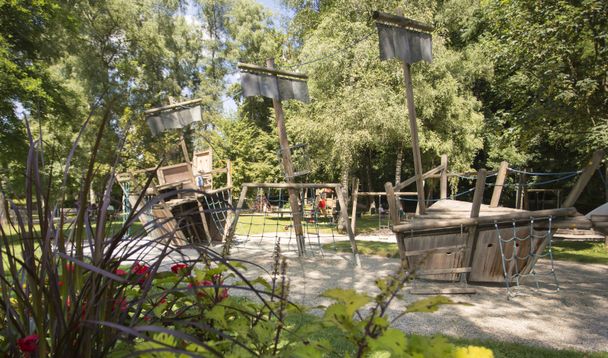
222;183;354;264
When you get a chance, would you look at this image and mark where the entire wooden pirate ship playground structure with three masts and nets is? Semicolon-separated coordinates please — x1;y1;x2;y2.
109;13;608;293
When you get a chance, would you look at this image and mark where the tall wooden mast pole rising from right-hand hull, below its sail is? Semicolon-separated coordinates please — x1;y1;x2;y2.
403;62;426;215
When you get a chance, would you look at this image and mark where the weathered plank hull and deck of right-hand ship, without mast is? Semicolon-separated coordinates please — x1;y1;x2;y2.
394;200;573;282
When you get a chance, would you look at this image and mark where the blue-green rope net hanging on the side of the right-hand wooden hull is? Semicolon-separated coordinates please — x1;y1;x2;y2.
494;217;559;296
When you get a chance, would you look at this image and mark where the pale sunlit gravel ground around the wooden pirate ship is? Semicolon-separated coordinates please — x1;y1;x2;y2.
223;235;608;351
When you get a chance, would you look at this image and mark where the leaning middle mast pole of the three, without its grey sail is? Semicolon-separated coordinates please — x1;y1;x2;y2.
266;58;304;256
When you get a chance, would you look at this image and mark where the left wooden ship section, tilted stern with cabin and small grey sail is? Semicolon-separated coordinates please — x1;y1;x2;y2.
116;100;232;244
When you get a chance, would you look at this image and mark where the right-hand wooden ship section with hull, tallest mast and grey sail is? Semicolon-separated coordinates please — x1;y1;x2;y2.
374;12;608;294
